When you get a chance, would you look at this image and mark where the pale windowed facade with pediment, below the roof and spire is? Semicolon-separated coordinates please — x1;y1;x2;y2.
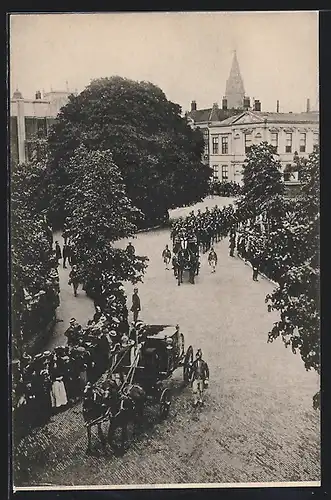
209;111;319;184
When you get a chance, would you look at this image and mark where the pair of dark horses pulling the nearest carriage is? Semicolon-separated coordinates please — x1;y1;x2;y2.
83;379;146;454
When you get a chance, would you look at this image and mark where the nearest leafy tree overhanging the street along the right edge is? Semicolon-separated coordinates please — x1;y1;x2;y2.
266;149;320;401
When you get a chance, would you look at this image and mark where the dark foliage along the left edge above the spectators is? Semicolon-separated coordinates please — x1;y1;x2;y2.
11;162;59;355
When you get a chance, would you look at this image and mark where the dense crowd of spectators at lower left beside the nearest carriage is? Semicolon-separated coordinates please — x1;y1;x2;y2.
13;308;148;438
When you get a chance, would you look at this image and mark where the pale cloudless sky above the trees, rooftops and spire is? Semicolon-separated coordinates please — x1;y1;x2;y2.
9;11;318;112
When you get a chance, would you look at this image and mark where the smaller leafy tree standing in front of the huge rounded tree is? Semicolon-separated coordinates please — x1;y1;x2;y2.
64;147;148;300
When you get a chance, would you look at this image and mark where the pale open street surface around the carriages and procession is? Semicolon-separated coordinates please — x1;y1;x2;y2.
17;199;320;486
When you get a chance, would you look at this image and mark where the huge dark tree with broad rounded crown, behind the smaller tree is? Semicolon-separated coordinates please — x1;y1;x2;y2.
45;76;210;229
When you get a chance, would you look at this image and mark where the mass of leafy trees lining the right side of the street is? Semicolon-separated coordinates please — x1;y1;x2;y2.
233;143;320;407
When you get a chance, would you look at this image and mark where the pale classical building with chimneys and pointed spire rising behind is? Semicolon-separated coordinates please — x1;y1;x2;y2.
186;52;319;184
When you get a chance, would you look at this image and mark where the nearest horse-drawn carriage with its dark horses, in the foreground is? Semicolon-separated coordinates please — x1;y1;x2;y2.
83;325;193;452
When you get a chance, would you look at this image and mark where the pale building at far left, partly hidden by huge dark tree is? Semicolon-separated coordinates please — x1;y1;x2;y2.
10;90;73;163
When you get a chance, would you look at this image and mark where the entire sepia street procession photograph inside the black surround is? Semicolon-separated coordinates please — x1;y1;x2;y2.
7;11;321;491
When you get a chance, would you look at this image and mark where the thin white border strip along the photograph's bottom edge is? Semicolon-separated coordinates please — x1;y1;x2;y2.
13;481;321;493
